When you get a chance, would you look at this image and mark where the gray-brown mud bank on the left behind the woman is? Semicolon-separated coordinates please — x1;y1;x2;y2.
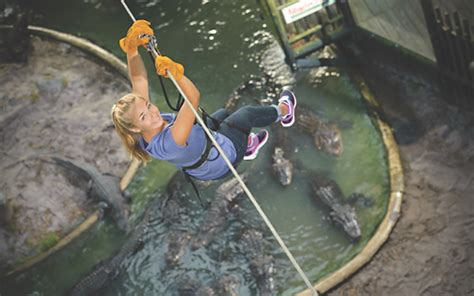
0;37;130;271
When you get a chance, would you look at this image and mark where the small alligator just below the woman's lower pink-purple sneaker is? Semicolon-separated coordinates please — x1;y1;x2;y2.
272;127;293;186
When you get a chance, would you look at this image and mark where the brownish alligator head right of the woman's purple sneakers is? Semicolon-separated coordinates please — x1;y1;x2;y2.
314;123;343;156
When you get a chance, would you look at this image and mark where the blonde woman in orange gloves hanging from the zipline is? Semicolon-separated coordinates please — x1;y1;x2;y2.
112;20;296;180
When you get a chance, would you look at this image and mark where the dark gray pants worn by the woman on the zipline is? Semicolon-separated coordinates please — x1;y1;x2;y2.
207;106;280;167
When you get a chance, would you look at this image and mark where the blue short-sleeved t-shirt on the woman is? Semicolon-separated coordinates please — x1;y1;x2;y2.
140;113;237;180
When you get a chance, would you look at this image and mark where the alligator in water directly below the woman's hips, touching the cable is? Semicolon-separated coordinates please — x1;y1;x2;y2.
191;174;247;250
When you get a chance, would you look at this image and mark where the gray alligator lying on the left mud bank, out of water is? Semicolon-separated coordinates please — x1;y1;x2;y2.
51;156;130;232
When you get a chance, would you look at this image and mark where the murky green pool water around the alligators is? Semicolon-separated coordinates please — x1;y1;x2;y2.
0;0;389;295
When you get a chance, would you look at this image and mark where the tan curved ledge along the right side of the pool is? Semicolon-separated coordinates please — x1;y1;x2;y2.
297;74;405;296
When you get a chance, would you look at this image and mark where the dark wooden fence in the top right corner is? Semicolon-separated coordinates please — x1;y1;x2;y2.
420;0;474;110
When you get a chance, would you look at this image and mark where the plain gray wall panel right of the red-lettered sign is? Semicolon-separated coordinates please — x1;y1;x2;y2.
349;0;434;61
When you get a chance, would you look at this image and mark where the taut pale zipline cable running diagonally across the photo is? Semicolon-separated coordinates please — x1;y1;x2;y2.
121;0;318;296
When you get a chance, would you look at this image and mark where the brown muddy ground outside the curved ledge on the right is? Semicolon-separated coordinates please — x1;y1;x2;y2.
328;42;474;295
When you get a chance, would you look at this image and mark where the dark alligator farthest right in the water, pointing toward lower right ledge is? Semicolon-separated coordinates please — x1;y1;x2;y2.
310;173;361;240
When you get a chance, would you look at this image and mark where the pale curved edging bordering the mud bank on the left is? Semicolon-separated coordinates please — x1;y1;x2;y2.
2;26;141;277
